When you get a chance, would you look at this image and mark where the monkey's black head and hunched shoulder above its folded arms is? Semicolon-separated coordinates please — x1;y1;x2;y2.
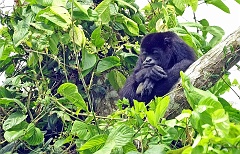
140;32;195;69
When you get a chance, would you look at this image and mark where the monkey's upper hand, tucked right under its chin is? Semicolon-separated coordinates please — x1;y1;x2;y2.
148;65;167;81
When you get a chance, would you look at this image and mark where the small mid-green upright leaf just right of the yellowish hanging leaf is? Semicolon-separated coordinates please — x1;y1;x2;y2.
91;27;105;48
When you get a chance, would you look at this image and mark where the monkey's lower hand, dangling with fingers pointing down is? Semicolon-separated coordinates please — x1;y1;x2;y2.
136;78;154;97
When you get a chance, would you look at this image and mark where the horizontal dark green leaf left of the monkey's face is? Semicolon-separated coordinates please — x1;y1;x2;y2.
97;56;121;73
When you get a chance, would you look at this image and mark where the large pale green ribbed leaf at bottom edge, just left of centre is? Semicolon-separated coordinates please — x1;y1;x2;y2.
95;124;134;154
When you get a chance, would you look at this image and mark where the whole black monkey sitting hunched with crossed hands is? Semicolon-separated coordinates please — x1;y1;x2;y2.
120;32;196;105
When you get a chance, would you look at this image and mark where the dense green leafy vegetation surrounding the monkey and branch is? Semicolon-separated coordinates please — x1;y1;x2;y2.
0;0;240;154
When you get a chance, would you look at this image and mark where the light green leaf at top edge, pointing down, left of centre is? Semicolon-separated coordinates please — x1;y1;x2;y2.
95;0;112;24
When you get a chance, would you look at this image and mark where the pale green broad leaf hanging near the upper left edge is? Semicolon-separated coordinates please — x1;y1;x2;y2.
13;20;30;47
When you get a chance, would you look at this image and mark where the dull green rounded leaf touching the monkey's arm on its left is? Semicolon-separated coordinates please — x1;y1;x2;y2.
107;70;126;90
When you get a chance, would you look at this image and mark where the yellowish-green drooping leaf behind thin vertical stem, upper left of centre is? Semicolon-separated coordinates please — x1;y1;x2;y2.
69;25;86;47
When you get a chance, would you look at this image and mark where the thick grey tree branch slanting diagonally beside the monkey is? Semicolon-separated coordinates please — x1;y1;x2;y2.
165;27;240;118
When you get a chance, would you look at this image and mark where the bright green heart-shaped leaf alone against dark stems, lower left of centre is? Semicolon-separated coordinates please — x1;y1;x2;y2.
57;83;87;111
